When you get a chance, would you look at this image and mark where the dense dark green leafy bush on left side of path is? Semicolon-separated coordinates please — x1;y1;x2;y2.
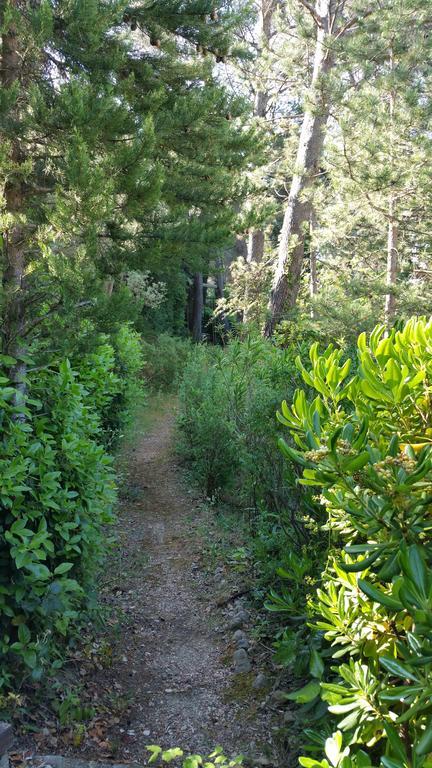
0;358;115;689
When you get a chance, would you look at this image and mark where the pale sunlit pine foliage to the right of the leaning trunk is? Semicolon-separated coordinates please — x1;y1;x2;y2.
308;0;432;334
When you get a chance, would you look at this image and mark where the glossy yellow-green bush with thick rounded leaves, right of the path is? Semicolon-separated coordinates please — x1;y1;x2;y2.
279;318;432;768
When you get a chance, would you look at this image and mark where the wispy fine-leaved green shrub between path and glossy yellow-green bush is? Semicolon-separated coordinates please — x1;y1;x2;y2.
179;337;308;514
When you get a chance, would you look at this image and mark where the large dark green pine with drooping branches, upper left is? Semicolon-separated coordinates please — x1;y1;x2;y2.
0;0;255;370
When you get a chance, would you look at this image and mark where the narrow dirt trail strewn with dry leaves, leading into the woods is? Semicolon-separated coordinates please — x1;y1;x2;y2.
86;409;271;764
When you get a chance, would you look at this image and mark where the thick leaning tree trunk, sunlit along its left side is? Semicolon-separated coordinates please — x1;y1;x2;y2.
264;0;337;337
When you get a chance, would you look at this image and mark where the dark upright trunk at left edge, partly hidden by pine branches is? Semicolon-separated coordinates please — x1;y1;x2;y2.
1;0;27;404
